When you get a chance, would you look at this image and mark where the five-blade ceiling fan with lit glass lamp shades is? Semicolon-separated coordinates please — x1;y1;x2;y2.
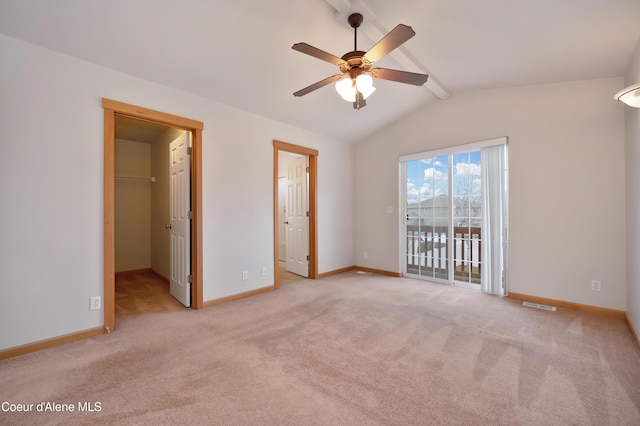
291;13;429;109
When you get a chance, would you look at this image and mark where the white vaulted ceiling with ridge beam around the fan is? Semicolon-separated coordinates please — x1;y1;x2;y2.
0;0;640;142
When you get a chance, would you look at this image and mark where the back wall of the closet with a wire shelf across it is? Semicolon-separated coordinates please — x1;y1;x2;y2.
115;139;153;272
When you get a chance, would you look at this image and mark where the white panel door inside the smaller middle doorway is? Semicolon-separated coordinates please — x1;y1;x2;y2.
285;157;309;277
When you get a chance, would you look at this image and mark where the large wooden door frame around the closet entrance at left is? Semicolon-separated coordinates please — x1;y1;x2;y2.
102;98;204;332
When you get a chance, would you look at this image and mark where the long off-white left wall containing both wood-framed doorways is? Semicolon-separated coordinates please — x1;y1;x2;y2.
0;35;353;349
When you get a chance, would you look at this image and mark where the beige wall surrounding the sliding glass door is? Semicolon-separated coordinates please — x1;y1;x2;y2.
354;78;627;310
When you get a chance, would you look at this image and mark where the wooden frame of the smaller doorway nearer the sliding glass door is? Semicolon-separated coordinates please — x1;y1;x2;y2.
273;140;318;289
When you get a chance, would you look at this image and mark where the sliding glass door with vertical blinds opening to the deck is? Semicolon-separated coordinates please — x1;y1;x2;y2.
401;138;507;293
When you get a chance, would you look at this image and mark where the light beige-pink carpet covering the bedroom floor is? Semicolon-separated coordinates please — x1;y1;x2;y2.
0;272;640;425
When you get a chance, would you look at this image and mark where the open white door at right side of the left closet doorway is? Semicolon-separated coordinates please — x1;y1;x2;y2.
169;132;191;307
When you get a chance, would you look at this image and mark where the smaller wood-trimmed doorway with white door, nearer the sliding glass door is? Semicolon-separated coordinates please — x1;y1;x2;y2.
273;140;318;288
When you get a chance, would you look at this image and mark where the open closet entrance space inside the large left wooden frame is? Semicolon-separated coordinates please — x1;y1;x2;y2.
114;116;191;317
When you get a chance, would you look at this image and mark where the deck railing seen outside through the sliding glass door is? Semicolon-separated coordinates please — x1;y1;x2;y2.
407;225;482;284
